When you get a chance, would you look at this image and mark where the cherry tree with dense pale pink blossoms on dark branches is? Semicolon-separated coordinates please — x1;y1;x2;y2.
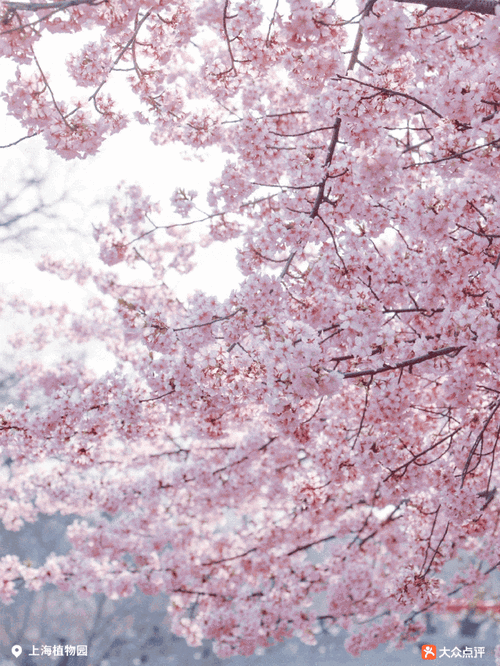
0;0;500;656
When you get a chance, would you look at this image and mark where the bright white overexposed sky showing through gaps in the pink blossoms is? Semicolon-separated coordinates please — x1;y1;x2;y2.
0;0;357;330
